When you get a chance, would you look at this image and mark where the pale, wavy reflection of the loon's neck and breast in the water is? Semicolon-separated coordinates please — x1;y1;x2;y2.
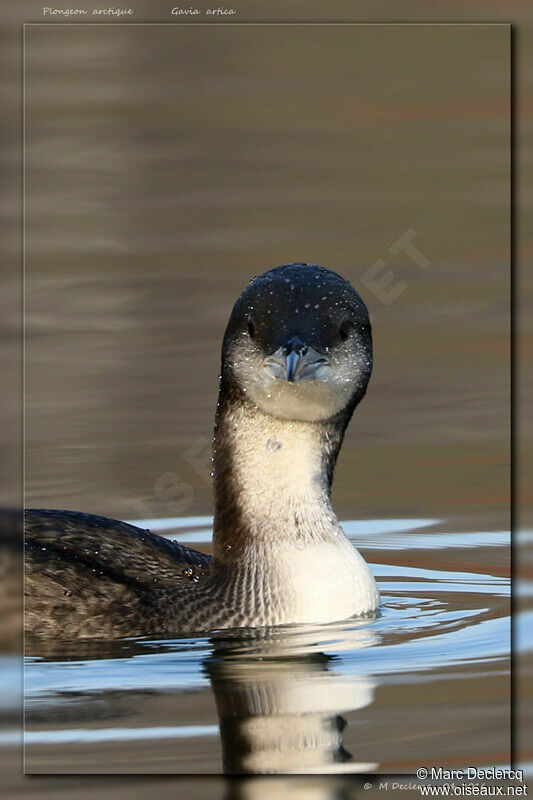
205;625;376;774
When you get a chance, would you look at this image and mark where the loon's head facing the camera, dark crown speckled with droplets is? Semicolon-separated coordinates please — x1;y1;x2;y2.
218;264;372;422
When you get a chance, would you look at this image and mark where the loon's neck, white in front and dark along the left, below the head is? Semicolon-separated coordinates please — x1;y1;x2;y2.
213;384;345;568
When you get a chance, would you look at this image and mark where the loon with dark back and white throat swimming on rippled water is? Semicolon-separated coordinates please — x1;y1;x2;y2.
25;263;379;638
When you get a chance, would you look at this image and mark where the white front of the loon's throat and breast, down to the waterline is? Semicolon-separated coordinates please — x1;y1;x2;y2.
211;404;379;625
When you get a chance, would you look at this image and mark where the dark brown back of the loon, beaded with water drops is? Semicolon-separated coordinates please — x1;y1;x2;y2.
24;509;211;638
